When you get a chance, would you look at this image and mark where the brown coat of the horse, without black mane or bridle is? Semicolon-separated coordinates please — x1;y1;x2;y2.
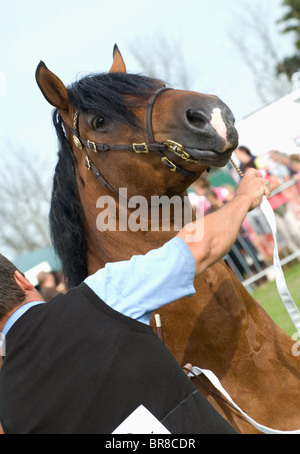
37;48;300;433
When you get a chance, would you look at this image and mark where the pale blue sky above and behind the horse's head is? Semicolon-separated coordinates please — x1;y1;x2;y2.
0;0;292;168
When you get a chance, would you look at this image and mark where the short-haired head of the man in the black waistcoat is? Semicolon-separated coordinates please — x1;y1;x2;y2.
0;254;42;319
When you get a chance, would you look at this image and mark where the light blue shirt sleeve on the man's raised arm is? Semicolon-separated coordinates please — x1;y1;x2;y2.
85;237;196;324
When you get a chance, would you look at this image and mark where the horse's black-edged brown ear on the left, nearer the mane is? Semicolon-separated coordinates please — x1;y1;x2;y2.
35;61;70;112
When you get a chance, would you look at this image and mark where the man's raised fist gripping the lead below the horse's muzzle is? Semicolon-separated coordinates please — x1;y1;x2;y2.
236;169;272;211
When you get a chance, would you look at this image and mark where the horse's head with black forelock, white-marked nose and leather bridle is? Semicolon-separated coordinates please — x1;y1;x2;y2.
36;46;238;200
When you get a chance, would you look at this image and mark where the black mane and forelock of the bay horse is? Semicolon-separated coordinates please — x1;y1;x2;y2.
49;73;161;288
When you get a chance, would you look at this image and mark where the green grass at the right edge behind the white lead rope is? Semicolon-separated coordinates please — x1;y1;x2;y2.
252;264;300;335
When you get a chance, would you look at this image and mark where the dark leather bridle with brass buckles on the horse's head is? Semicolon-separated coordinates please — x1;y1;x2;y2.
71;87;207;194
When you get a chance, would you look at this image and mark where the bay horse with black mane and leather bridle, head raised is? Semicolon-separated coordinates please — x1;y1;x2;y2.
36;46;300;434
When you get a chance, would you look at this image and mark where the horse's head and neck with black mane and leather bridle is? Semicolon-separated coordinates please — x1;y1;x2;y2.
36;46;238;286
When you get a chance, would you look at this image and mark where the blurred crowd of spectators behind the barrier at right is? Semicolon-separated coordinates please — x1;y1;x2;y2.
189;146;300;278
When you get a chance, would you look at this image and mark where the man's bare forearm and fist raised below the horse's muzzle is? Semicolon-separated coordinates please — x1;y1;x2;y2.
178;169;271;275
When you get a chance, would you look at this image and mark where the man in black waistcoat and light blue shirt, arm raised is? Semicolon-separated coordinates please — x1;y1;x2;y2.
0;169;270;434
